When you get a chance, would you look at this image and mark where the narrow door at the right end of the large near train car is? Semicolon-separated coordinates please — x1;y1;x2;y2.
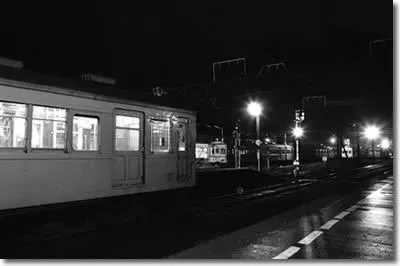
176;118;190;182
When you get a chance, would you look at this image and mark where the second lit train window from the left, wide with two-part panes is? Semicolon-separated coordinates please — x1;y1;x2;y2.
31;106;67;149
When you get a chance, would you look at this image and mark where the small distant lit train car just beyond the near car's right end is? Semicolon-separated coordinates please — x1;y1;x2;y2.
196;141;227;168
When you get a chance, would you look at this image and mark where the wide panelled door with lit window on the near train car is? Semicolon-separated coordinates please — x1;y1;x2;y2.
113;110;144;187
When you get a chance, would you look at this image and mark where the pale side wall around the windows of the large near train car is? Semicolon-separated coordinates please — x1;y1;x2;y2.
0;81;196;210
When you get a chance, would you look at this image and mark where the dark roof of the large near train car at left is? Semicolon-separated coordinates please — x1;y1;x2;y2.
0;66;196;115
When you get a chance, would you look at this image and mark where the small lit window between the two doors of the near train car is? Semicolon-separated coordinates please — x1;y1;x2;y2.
150;120;171;152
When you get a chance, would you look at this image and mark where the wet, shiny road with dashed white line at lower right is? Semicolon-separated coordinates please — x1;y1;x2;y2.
168;177;394;260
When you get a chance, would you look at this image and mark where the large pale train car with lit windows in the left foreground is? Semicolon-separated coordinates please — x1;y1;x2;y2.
0;71;196;210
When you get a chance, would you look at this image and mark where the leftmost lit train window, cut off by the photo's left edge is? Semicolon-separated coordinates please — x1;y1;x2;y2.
0;102;28;148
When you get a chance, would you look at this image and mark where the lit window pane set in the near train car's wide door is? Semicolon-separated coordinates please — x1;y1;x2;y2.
115;115;140;151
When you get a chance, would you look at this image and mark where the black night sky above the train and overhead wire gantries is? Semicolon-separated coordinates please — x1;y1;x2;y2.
0;0;393;135
